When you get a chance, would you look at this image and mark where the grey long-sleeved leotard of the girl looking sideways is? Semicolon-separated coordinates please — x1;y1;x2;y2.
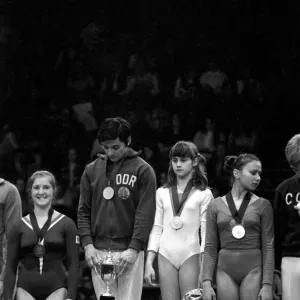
203;198;274;285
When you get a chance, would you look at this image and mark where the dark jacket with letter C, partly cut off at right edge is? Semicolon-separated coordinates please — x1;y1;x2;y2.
273;175;300;270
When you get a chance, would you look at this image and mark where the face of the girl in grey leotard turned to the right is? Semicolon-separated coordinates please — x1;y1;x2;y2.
234;160;262;191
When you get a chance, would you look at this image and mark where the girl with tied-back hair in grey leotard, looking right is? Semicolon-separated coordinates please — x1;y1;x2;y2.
202;154;274;300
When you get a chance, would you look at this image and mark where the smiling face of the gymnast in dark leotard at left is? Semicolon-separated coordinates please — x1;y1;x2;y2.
31;176;54;208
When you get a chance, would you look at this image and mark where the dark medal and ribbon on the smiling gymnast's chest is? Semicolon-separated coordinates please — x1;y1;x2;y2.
30;207;53;258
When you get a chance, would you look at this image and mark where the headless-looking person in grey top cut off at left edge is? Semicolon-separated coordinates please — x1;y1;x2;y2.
0;178;22;299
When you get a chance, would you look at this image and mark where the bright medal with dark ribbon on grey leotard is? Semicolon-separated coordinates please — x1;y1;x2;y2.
226;192;251;240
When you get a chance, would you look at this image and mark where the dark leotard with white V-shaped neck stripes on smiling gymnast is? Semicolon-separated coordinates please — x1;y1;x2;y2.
4;214;79;300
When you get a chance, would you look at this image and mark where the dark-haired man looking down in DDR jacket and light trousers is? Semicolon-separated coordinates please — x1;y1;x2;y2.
78;117;156;300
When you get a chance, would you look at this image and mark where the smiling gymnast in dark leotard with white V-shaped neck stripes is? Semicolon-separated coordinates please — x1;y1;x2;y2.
4;171;79;300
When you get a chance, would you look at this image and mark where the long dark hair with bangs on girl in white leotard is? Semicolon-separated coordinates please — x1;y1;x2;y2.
165;141;208;190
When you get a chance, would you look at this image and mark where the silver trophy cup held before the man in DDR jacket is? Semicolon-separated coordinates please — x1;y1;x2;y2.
95;251;119;300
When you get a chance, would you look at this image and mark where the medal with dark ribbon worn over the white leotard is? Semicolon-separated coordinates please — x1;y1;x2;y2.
170;180;193;230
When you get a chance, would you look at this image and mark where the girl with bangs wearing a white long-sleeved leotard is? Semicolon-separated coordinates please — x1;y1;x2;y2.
145;141;213;300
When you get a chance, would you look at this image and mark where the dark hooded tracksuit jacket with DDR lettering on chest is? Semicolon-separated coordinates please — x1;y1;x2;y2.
78;149;156;251
